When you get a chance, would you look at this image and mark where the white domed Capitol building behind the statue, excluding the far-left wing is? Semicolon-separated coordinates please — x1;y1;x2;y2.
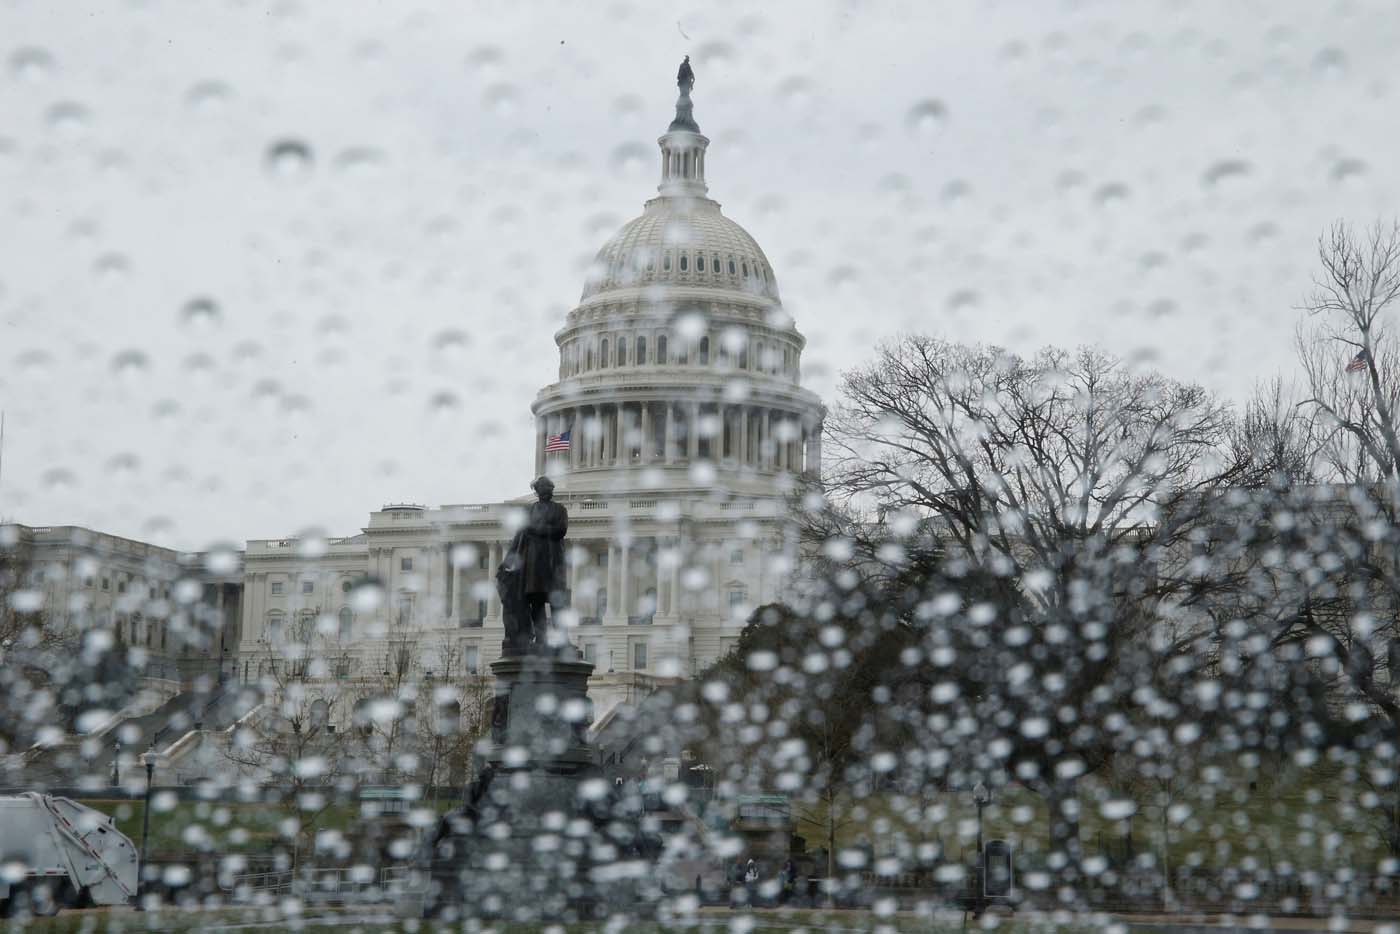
237;66;825;703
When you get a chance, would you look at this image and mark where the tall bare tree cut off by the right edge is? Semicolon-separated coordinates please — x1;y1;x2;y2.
1281;223;1400;856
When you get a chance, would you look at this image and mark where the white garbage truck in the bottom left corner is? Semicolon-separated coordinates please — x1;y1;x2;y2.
0;791;140;916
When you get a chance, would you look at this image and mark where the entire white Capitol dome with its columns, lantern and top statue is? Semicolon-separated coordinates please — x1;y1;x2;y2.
531;64;826;503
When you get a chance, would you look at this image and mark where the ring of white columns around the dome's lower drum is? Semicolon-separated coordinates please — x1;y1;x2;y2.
535;402;822;473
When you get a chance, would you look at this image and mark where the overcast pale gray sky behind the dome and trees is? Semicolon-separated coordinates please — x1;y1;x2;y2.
0;0;1400;548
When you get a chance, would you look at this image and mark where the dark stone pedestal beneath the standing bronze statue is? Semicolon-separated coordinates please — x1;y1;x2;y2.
424;655;652;921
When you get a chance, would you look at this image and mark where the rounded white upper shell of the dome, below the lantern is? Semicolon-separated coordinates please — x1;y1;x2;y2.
580;197;778;301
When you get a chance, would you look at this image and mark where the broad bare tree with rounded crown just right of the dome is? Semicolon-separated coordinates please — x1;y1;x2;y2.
809;336;1261;861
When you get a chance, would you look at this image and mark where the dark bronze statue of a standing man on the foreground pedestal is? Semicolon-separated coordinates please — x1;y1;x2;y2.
496;476;568;655
